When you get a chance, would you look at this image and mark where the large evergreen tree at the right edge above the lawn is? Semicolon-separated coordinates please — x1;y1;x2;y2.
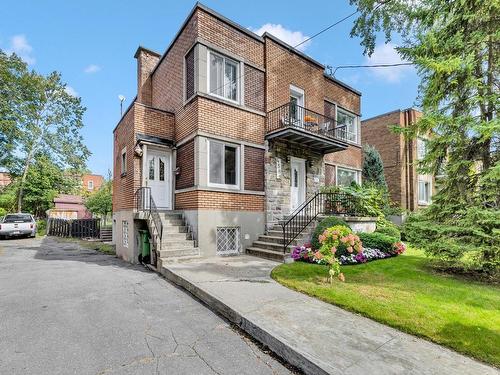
351;0;500;276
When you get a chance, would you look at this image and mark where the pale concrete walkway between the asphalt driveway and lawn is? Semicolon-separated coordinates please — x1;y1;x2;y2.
162;256;500;375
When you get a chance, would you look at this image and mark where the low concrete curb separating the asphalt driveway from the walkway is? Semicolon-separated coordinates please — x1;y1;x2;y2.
160;266;332;375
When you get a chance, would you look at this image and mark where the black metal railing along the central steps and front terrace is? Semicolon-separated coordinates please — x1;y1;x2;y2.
280;192;357;253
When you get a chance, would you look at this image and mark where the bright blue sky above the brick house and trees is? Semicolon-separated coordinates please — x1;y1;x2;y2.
0;0;418;175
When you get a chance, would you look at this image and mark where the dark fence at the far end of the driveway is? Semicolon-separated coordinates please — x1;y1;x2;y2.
47;218;101;238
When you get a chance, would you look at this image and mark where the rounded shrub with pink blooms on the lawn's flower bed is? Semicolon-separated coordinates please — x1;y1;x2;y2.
319;225;363;258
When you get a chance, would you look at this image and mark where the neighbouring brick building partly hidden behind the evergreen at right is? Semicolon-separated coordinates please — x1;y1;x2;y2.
361;108;435;211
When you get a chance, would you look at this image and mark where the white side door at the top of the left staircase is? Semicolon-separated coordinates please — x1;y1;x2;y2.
146;150;172;210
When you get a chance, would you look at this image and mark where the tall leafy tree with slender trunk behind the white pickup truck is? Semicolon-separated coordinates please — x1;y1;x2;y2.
0;49;90;211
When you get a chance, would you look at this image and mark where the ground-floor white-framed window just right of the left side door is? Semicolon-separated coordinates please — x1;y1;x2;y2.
208;141;239;188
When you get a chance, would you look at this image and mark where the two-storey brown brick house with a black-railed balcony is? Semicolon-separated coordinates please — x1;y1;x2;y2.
113;3;361;262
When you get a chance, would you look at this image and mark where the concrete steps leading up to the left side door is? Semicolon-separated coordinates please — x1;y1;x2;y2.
150;211;200;269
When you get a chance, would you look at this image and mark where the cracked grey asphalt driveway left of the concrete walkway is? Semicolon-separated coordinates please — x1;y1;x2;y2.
0;238;290;375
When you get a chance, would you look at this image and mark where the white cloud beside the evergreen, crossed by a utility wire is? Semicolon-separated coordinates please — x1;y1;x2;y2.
366;43;413;83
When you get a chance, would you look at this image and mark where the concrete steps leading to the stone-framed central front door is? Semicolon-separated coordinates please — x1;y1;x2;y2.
246;225;310;262
